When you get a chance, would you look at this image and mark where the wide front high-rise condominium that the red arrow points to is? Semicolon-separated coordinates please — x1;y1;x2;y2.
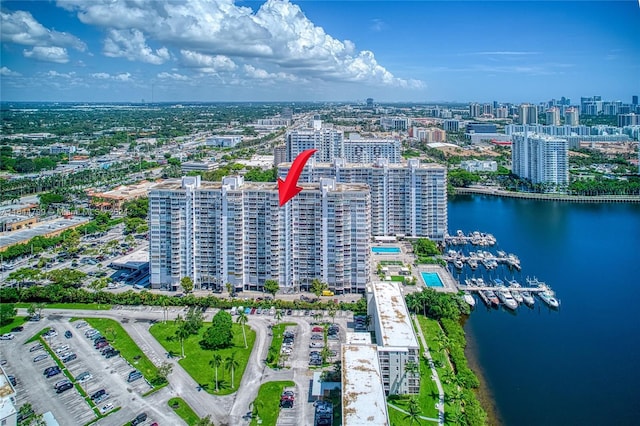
149;176;371;294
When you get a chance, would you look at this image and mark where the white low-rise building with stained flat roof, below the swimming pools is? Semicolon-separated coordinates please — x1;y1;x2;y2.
367;281;420;395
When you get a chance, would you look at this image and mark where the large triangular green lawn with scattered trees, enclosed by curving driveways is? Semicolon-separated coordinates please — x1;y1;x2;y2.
149;322;256;395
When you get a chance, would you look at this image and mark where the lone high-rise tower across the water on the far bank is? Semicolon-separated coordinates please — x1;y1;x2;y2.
511;133;569;189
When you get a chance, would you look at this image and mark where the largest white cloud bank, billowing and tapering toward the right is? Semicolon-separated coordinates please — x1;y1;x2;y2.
58;0;423;88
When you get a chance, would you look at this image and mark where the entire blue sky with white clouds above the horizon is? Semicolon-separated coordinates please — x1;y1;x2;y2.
0;0;640;102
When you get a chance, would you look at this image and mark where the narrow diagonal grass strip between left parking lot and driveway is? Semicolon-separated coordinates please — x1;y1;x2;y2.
82;318;158;381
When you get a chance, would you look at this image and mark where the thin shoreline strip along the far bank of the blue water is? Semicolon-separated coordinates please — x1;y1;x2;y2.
452;187;640;203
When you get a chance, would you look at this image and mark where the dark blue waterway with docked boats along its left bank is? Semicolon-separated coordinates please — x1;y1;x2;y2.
449;195;640;425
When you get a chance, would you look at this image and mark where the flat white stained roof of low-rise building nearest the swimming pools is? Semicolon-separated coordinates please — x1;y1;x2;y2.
371;281;418;348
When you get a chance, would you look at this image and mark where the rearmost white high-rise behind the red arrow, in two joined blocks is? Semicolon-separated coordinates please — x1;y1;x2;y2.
286;128;402;163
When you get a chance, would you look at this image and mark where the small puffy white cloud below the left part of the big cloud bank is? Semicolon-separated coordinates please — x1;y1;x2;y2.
103;29;170;65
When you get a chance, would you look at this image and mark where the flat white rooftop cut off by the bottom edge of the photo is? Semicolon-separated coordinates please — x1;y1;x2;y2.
342;345;389;426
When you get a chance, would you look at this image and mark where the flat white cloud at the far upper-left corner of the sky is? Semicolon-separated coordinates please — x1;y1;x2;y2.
0;10;87;52
